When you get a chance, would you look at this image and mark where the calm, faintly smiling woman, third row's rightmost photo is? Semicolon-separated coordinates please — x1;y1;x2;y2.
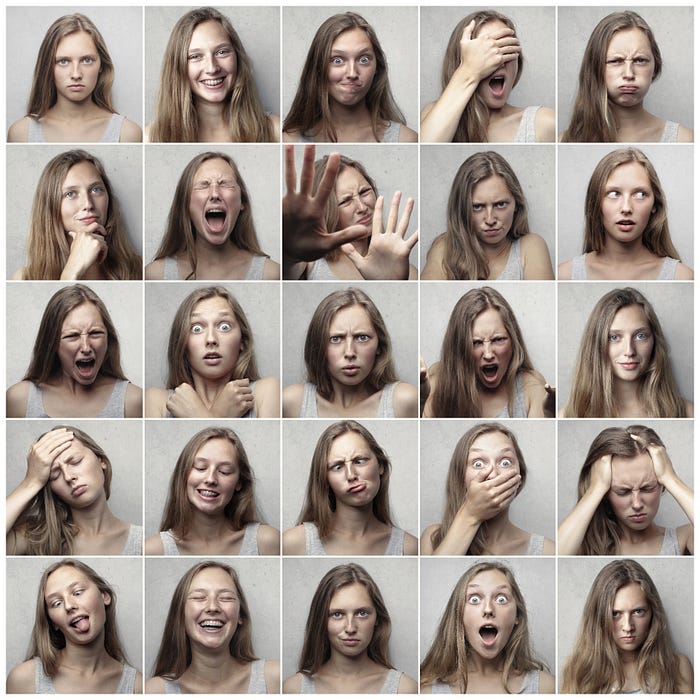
563;287;693;418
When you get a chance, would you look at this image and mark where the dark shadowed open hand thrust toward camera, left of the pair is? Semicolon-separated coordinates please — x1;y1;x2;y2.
282;145;367;265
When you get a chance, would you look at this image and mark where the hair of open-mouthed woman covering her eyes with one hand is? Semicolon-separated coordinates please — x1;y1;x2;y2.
442;10;523;143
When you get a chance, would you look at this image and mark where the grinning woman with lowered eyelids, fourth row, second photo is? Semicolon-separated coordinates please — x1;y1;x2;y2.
146;428;280;556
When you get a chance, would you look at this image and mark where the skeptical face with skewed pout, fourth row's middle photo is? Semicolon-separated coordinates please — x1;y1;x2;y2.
326;430;384;507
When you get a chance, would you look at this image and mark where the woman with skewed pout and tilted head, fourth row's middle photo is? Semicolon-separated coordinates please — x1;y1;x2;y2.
283;420;418;556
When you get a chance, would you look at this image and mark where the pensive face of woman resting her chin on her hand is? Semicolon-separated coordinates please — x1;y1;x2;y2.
61;160;109;233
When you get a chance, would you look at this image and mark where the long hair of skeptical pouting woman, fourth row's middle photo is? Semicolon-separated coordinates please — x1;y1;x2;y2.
297;420;393;539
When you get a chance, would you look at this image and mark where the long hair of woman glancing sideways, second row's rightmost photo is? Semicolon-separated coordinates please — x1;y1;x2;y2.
583;146;680;260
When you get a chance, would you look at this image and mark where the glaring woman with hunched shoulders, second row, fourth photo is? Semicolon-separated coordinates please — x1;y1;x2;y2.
421;151;554;280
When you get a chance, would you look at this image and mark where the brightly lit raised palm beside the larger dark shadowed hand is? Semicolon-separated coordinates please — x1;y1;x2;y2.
340;192;418;280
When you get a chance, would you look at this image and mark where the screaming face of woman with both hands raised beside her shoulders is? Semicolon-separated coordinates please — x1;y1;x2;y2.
471;308;513;391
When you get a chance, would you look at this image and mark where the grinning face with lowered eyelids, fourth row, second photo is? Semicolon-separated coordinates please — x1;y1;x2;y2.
186;438;241;515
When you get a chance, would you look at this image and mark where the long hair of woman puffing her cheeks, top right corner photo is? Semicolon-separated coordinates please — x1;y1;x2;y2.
561;10;662;142
